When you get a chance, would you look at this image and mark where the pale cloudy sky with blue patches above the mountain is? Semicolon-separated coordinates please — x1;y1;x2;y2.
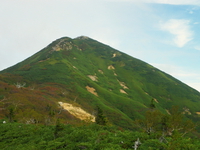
0;0;200;91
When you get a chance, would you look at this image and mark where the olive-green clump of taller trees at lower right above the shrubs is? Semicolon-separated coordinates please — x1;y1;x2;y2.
135;106;195;140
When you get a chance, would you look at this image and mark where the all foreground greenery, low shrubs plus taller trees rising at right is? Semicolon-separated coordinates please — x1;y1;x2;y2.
0;103;200;150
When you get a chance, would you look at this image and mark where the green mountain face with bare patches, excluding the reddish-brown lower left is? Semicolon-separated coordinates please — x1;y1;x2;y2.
1;36;200;127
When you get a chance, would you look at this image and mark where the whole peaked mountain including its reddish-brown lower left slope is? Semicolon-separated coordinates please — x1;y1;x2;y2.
0;36;200;128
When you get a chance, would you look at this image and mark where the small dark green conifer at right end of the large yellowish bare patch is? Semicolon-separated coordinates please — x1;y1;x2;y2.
95;106;108;125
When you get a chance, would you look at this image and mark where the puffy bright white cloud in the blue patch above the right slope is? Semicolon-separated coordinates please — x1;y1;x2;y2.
160;19;193;47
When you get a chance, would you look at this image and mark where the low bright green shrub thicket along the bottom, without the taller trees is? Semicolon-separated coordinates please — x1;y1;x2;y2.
0;120;200;150
